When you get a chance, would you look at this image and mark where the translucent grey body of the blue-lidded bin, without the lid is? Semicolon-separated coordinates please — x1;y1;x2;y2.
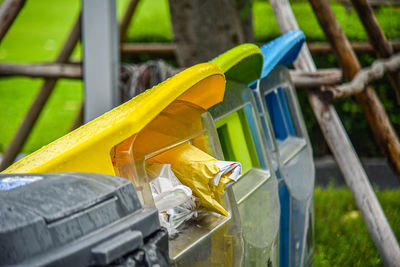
258;65;315;266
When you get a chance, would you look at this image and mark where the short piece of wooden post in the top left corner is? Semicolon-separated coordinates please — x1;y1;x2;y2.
0;0;25;41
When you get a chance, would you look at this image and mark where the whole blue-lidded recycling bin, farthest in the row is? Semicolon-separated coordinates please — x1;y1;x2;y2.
251;31;315;266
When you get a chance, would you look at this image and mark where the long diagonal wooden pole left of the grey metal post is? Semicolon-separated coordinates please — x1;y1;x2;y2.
0;15;81;171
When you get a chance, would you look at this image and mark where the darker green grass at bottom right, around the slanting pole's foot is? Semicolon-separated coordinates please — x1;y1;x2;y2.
314;187;400;266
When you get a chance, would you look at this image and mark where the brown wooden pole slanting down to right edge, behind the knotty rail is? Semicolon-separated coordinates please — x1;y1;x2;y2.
310;0;400;180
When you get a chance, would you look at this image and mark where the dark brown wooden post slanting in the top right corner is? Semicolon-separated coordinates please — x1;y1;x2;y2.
351;0;400;101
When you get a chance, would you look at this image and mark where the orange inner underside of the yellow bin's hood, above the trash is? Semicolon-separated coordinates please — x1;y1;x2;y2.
111;100;210;206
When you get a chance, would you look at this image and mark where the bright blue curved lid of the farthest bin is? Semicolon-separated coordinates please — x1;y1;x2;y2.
251;30;305;85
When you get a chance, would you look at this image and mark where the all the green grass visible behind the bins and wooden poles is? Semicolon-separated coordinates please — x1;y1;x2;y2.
0;0;400;266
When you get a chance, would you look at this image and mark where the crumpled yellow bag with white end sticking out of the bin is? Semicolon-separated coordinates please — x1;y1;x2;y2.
148;143;242;216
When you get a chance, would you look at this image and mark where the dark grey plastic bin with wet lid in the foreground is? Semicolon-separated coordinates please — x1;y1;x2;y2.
0;173;169;266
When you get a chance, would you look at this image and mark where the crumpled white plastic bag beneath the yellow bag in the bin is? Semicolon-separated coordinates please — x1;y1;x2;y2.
146;164;197;236
